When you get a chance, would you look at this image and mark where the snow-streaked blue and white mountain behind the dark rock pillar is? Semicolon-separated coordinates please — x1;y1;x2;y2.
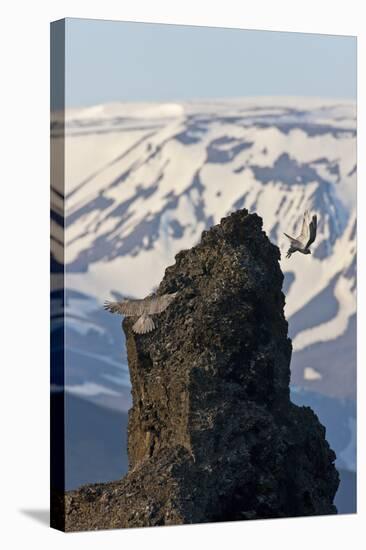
52;98;356;472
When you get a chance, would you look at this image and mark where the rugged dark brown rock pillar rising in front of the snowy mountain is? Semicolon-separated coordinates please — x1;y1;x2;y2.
65;210;339;530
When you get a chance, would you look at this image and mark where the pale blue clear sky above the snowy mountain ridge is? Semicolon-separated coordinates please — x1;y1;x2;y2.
66;19;356;107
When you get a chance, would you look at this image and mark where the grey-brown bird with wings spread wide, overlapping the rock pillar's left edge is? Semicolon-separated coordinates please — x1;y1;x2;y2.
104;292;178;334
